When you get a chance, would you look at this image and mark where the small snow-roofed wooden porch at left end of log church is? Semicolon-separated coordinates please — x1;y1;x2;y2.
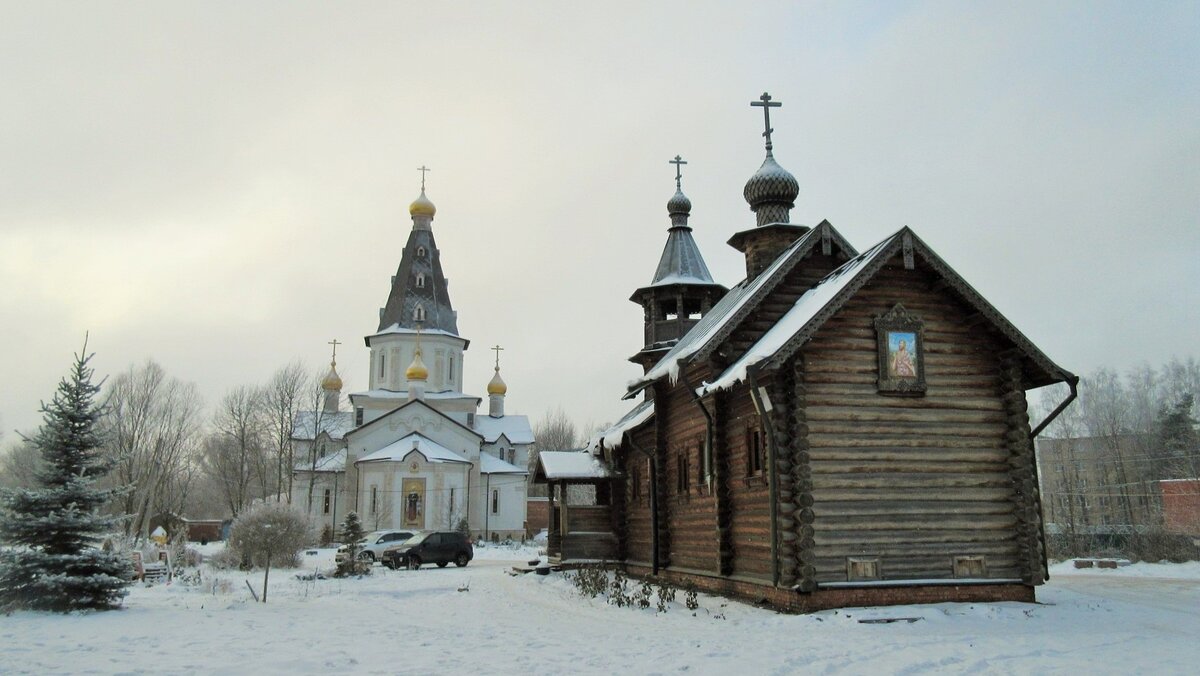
533;450;617;564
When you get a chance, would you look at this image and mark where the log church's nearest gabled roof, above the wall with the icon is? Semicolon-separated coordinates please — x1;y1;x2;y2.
700;227;1074;393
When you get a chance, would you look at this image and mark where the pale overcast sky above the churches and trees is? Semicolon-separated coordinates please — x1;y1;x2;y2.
0;1;1200;442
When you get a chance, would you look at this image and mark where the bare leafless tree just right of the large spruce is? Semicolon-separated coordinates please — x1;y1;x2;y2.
98;360;203;538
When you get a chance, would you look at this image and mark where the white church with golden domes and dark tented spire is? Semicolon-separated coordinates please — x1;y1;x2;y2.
292;180;534;540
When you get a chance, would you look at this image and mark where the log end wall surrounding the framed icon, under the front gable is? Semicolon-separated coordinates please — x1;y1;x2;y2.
803;258;1024;582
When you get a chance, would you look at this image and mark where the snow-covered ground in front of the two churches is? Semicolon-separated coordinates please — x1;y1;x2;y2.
0;548;1200;676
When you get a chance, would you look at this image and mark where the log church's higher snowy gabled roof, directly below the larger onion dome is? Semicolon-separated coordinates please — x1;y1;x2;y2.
625;221;857;399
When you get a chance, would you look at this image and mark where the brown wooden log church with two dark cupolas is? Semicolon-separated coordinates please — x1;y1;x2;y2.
535;95;1078;610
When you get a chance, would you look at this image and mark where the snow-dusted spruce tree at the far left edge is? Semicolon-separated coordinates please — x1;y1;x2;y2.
0;342;131;612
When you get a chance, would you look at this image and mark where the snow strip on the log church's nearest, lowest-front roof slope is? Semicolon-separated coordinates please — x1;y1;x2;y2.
696;235;896;394
